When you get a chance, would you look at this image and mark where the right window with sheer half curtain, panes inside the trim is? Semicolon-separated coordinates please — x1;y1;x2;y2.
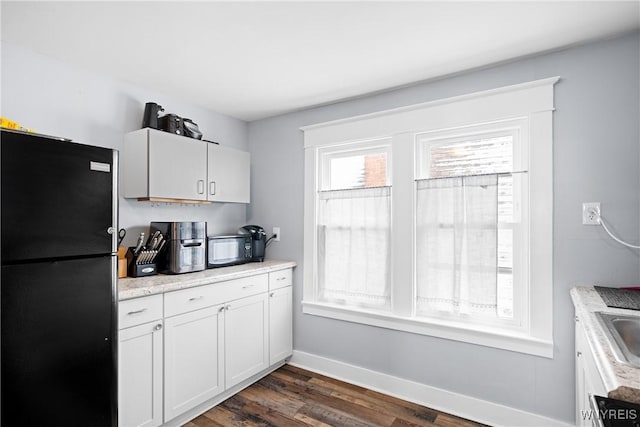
415;119;528;327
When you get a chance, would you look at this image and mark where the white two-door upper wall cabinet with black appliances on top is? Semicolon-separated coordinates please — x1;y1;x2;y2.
122;128;250;203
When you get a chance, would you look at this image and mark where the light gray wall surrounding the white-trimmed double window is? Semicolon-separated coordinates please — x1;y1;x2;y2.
247;33;640;422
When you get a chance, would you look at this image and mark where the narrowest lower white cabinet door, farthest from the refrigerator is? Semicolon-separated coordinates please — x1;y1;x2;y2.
269;286;293;365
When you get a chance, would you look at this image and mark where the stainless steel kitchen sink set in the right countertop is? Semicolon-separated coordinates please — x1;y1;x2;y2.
594;312;640;368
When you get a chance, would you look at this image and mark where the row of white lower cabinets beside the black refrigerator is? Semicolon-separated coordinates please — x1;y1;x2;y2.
118;269;292;427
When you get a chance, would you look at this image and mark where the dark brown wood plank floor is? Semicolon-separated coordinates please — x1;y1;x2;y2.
185;365;482;427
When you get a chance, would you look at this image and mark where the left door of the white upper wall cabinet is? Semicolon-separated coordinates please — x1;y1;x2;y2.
149;130;208;200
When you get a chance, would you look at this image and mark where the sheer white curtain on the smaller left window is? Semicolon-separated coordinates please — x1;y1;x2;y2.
318;187;391;307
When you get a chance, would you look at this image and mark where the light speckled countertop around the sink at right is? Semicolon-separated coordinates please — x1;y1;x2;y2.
571;286;640;404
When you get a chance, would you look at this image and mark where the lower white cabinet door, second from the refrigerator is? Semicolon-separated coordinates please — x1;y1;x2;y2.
164;305;224;421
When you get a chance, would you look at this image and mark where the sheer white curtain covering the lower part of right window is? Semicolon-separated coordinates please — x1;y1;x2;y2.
416;174;498;315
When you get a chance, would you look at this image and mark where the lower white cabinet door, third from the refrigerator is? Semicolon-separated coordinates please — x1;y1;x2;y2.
225;293;269;388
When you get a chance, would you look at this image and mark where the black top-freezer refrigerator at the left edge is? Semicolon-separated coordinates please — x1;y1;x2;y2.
0;130;118;427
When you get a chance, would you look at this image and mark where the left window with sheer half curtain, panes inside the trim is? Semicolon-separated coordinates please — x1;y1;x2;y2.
317;142;391;308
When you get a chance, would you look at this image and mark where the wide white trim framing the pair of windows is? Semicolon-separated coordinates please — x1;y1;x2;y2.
301;77;559;358
